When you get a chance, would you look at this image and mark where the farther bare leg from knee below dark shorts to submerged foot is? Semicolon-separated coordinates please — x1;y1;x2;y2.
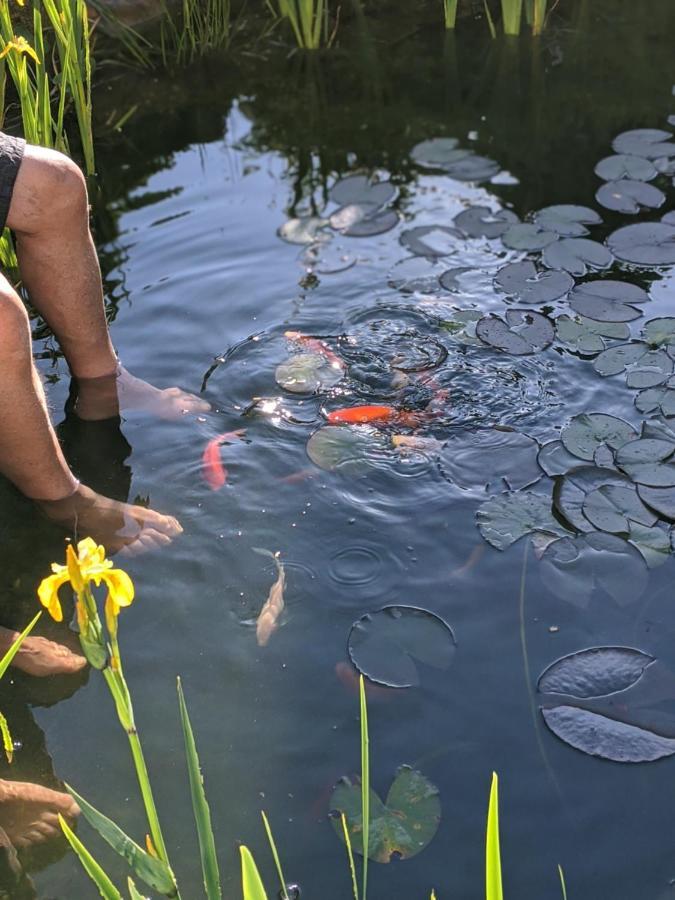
7;145;209;419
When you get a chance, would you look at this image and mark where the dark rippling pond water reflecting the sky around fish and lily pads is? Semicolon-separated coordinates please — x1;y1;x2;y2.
0;0;675;900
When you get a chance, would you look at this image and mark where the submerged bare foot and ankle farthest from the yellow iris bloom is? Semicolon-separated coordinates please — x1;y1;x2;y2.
74;366;211;421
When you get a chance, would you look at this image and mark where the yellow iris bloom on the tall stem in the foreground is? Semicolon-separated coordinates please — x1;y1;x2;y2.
38;538;134;625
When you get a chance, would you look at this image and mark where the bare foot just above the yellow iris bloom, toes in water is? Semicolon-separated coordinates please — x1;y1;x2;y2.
36;484;183;556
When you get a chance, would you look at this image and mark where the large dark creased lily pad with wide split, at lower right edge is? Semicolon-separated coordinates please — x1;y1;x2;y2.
537;647;675;763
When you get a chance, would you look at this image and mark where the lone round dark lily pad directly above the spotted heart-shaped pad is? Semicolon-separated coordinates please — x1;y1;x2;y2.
347;606;456;688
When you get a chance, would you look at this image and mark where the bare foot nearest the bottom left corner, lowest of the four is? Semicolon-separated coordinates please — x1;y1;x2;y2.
0;779;80;850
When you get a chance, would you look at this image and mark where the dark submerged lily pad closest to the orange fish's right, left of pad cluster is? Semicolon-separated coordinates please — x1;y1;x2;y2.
439;428;542;491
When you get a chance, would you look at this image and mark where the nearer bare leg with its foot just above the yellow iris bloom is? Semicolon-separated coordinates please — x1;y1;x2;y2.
0;275;182;552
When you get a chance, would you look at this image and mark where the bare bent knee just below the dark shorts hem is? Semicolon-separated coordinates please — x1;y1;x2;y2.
7;145;88;234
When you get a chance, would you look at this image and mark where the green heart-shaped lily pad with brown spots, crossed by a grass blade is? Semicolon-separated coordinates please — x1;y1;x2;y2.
330;766;441;863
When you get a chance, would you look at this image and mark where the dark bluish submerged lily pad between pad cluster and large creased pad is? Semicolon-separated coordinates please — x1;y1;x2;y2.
540;531;649;609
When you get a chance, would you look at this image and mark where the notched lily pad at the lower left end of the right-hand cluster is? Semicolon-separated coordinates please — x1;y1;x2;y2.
476;492;569;550
